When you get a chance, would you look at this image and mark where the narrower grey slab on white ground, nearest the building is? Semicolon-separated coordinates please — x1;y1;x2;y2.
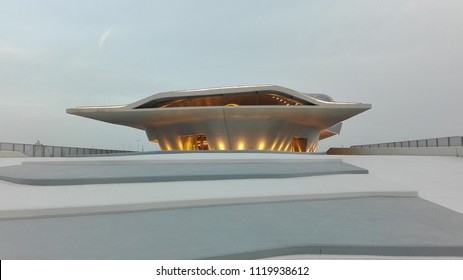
0;158;368;186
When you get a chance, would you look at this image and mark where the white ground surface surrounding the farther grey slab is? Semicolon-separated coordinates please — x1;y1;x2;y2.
0;153;463;213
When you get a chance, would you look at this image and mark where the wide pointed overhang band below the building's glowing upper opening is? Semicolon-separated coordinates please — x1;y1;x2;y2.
68;104;370;132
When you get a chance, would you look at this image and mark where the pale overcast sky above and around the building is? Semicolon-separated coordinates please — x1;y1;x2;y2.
0;0;463;150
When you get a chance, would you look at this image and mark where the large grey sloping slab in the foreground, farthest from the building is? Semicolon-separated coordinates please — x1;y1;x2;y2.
0;197;463;259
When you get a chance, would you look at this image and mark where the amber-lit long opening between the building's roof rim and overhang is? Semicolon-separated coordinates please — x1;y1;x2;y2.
135;91;314;109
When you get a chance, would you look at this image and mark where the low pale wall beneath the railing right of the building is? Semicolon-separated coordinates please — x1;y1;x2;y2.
327;147;463;157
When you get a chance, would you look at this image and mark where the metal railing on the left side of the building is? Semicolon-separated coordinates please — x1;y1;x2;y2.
0;142;133;157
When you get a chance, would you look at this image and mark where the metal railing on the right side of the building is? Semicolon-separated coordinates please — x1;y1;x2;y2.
351;136;463;148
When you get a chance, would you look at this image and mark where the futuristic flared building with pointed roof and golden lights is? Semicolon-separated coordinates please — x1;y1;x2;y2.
67;85;371;152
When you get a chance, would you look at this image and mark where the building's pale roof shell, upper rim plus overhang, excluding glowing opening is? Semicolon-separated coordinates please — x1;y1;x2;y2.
66;85;371;140
